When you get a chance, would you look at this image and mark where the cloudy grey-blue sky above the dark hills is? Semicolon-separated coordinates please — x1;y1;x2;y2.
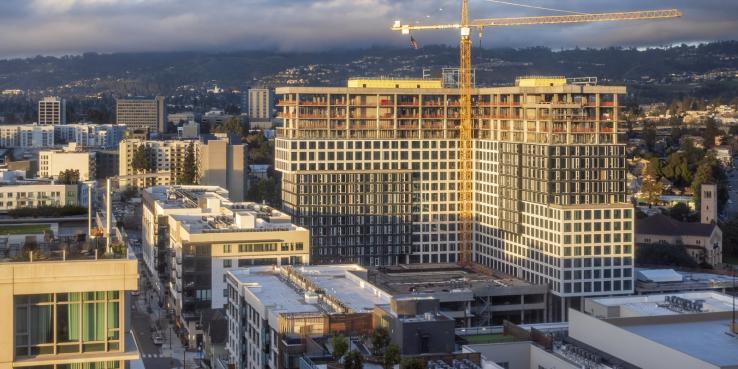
0;0;738;58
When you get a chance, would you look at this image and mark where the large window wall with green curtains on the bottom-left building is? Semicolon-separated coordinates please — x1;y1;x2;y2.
14;291;122;356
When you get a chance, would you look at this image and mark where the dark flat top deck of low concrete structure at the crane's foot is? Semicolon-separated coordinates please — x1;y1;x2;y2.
369;264;532;295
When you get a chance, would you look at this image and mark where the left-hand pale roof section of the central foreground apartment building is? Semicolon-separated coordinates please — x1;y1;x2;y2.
229;268;321;313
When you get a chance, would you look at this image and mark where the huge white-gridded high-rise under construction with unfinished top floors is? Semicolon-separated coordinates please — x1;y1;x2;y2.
275;77;634;314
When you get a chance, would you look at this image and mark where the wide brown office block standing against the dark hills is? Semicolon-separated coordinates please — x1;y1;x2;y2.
116;96;168;133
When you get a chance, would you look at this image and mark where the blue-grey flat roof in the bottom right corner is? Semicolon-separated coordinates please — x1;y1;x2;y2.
620;319;738;367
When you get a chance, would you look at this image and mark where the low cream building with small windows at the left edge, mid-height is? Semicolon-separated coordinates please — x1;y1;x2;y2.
0;184;79;213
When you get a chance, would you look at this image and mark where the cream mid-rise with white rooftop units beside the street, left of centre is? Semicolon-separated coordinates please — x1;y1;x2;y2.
142;186;310;347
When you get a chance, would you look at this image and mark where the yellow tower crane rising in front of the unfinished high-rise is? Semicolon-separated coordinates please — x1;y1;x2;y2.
391;0;682;266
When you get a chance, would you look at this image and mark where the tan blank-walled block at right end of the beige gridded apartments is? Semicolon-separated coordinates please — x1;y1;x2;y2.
198;133;249;201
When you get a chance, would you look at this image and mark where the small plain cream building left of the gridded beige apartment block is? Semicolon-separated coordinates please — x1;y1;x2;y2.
38;145;97;181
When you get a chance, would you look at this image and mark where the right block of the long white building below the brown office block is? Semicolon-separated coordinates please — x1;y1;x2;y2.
54;123;127;149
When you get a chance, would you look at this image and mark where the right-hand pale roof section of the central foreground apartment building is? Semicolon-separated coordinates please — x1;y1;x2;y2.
294;264;391;312
